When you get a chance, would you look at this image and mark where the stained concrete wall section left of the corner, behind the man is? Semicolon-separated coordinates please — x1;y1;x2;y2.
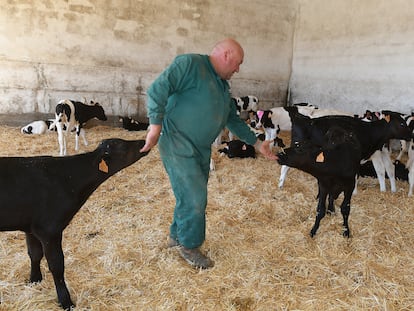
0;0;297;116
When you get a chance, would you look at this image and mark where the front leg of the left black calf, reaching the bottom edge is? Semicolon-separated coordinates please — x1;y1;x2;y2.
43;234;75;310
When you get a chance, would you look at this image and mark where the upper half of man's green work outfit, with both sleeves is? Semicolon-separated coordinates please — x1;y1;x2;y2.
147;54;256;149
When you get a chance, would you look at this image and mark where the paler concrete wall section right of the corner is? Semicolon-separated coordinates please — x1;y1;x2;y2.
290;0;414;113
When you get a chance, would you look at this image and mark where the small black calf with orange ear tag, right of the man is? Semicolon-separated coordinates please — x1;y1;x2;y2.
278;127;361;237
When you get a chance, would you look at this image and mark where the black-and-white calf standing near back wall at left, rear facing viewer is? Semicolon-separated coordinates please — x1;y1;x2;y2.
52;99;107;156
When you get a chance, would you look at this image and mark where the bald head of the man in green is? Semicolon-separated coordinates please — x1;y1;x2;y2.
210;38;244;80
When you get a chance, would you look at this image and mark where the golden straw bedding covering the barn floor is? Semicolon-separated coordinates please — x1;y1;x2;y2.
0;126;414;310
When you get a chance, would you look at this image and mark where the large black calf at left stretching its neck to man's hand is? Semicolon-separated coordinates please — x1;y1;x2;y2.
0;139;147;309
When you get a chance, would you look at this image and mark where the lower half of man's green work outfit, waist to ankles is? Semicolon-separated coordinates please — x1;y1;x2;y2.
159;134;211;248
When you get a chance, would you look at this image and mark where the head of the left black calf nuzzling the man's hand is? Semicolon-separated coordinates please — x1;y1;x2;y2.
96;138;148;176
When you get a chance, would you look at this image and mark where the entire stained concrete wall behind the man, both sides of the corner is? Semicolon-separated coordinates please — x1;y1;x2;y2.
0;0;414;120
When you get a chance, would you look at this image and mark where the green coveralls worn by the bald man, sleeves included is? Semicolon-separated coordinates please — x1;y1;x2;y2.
147;54;256;248
